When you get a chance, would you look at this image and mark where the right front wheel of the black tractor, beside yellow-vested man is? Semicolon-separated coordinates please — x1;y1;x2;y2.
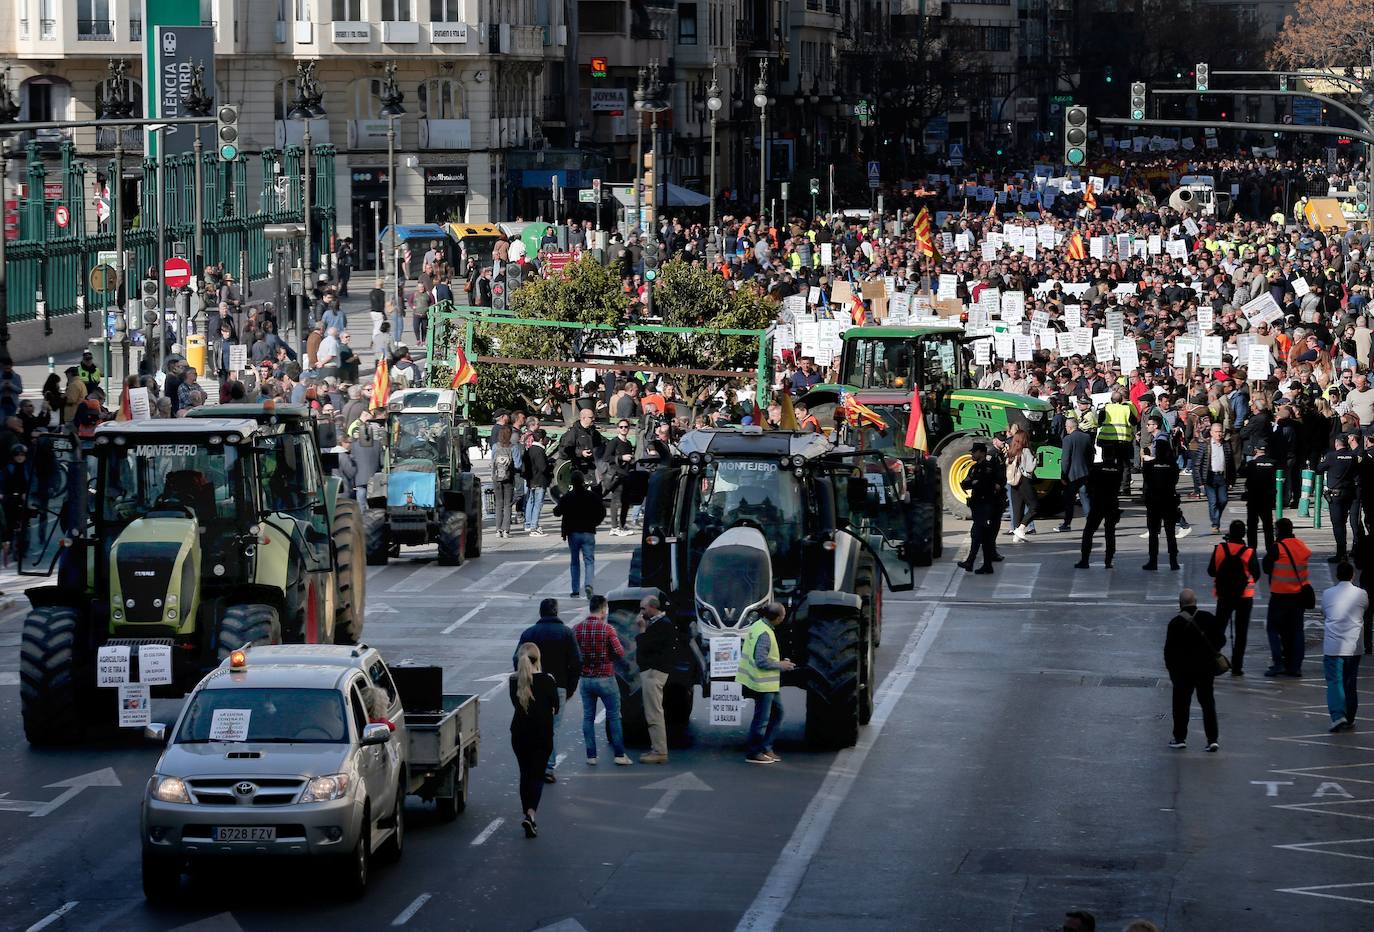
807;614;864;748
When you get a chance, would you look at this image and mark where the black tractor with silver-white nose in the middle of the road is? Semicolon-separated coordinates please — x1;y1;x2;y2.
606;426;940;748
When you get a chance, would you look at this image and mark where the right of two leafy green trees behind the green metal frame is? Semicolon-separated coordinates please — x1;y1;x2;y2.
638;260;778;399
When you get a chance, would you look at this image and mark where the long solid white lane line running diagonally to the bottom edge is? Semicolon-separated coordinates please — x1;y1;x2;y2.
735;605;949;932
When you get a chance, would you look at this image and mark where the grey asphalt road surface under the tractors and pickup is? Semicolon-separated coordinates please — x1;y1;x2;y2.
0;506;1374;932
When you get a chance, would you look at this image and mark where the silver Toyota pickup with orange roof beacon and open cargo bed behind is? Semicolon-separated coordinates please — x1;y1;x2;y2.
142;645;478;900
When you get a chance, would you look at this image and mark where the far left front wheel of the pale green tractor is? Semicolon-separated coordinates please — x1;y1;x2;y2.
19;606;87;746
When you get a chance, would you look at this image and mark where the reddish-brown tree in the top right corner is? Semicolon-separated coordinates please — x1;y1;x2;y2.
1270;0;1374;74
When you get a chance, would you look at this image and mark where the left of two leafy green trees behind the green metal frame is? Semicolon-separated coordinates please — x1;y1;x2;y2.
429;254;625;418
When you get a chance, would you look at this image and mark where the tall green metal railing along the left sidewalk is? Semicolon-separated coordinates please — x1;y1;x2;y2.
5;142;337;323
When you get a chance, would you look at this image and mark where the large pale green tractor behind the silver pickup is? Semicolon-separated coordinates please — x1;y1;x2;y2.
19;417;363;745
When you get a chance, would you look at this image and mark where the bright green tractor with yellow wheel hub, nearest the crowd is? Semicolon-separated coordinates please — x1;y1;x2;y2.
824;324;1059;518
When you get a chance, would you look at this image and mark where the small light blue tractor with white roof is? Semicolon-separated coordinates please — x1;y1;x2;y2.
363;388;482;566
